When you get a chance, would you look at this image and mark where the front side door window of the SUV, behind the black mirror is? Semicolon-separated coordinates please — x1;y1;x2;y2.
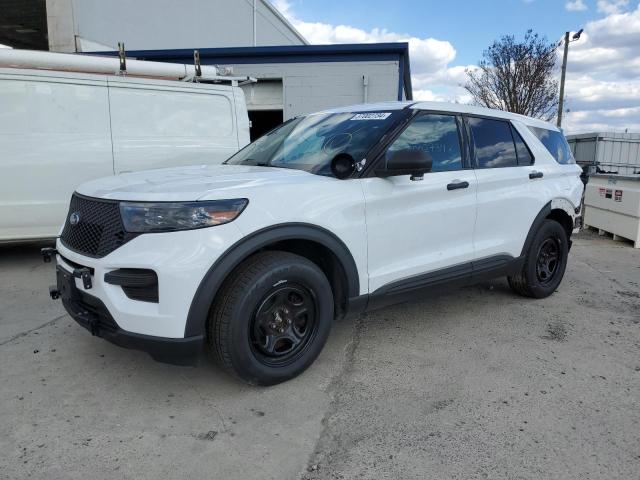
386;115;462;172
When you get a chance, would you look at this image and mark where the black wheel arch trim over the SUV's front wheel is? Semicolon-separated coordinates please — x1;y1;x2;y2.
184;223;360;337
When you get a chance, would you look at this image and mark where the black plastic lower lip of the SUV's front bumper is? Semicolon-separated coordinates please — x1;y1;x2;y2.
62;284;204;365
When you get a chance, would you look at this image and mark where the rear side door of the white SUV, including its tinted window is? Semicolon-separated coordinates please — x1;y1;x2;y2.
465;116;549;259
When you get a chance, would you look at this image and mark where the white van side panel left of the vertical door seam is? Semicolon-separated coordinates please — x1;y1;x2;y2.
0;69;113;240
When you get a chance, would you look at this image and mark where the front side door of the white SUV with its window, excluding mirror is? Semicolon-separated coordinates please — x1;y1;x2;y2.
362;113;476;292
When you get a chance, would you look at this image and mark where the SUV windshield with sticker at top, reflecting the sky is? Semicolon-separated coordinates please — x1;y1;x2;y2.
225;110;402;176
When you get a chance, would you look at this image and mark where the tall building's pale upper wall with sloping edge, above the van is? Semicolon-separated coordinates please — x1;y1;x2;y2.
46;0;305;52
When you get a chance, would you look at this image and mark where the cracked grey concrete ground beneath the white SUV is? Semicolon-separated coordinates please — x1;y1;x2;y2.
0;232;640;480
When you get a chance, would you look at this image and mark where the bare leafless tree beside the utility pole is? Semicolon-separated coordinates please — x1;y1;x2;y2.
465;30;558;120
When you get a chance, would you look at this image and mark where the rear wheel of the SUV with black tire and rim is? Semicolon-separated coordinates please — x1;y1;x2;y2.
507;220;569;298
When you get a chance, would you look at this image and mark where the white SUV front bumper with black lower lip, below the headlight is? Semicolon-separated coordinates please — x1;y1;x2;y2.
48;224;241;364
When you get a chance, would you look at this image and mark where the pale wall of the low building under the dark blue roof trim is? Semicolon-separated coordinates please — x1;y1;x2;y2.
231;61;399;120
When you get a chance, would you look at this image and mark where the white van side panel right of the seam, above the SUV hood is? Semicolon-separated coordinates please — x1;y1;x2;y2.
108;77;238;174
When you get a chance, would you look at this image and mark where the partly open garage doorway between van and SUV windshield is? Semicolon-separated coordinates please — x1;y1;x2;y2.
242;78;284;141
